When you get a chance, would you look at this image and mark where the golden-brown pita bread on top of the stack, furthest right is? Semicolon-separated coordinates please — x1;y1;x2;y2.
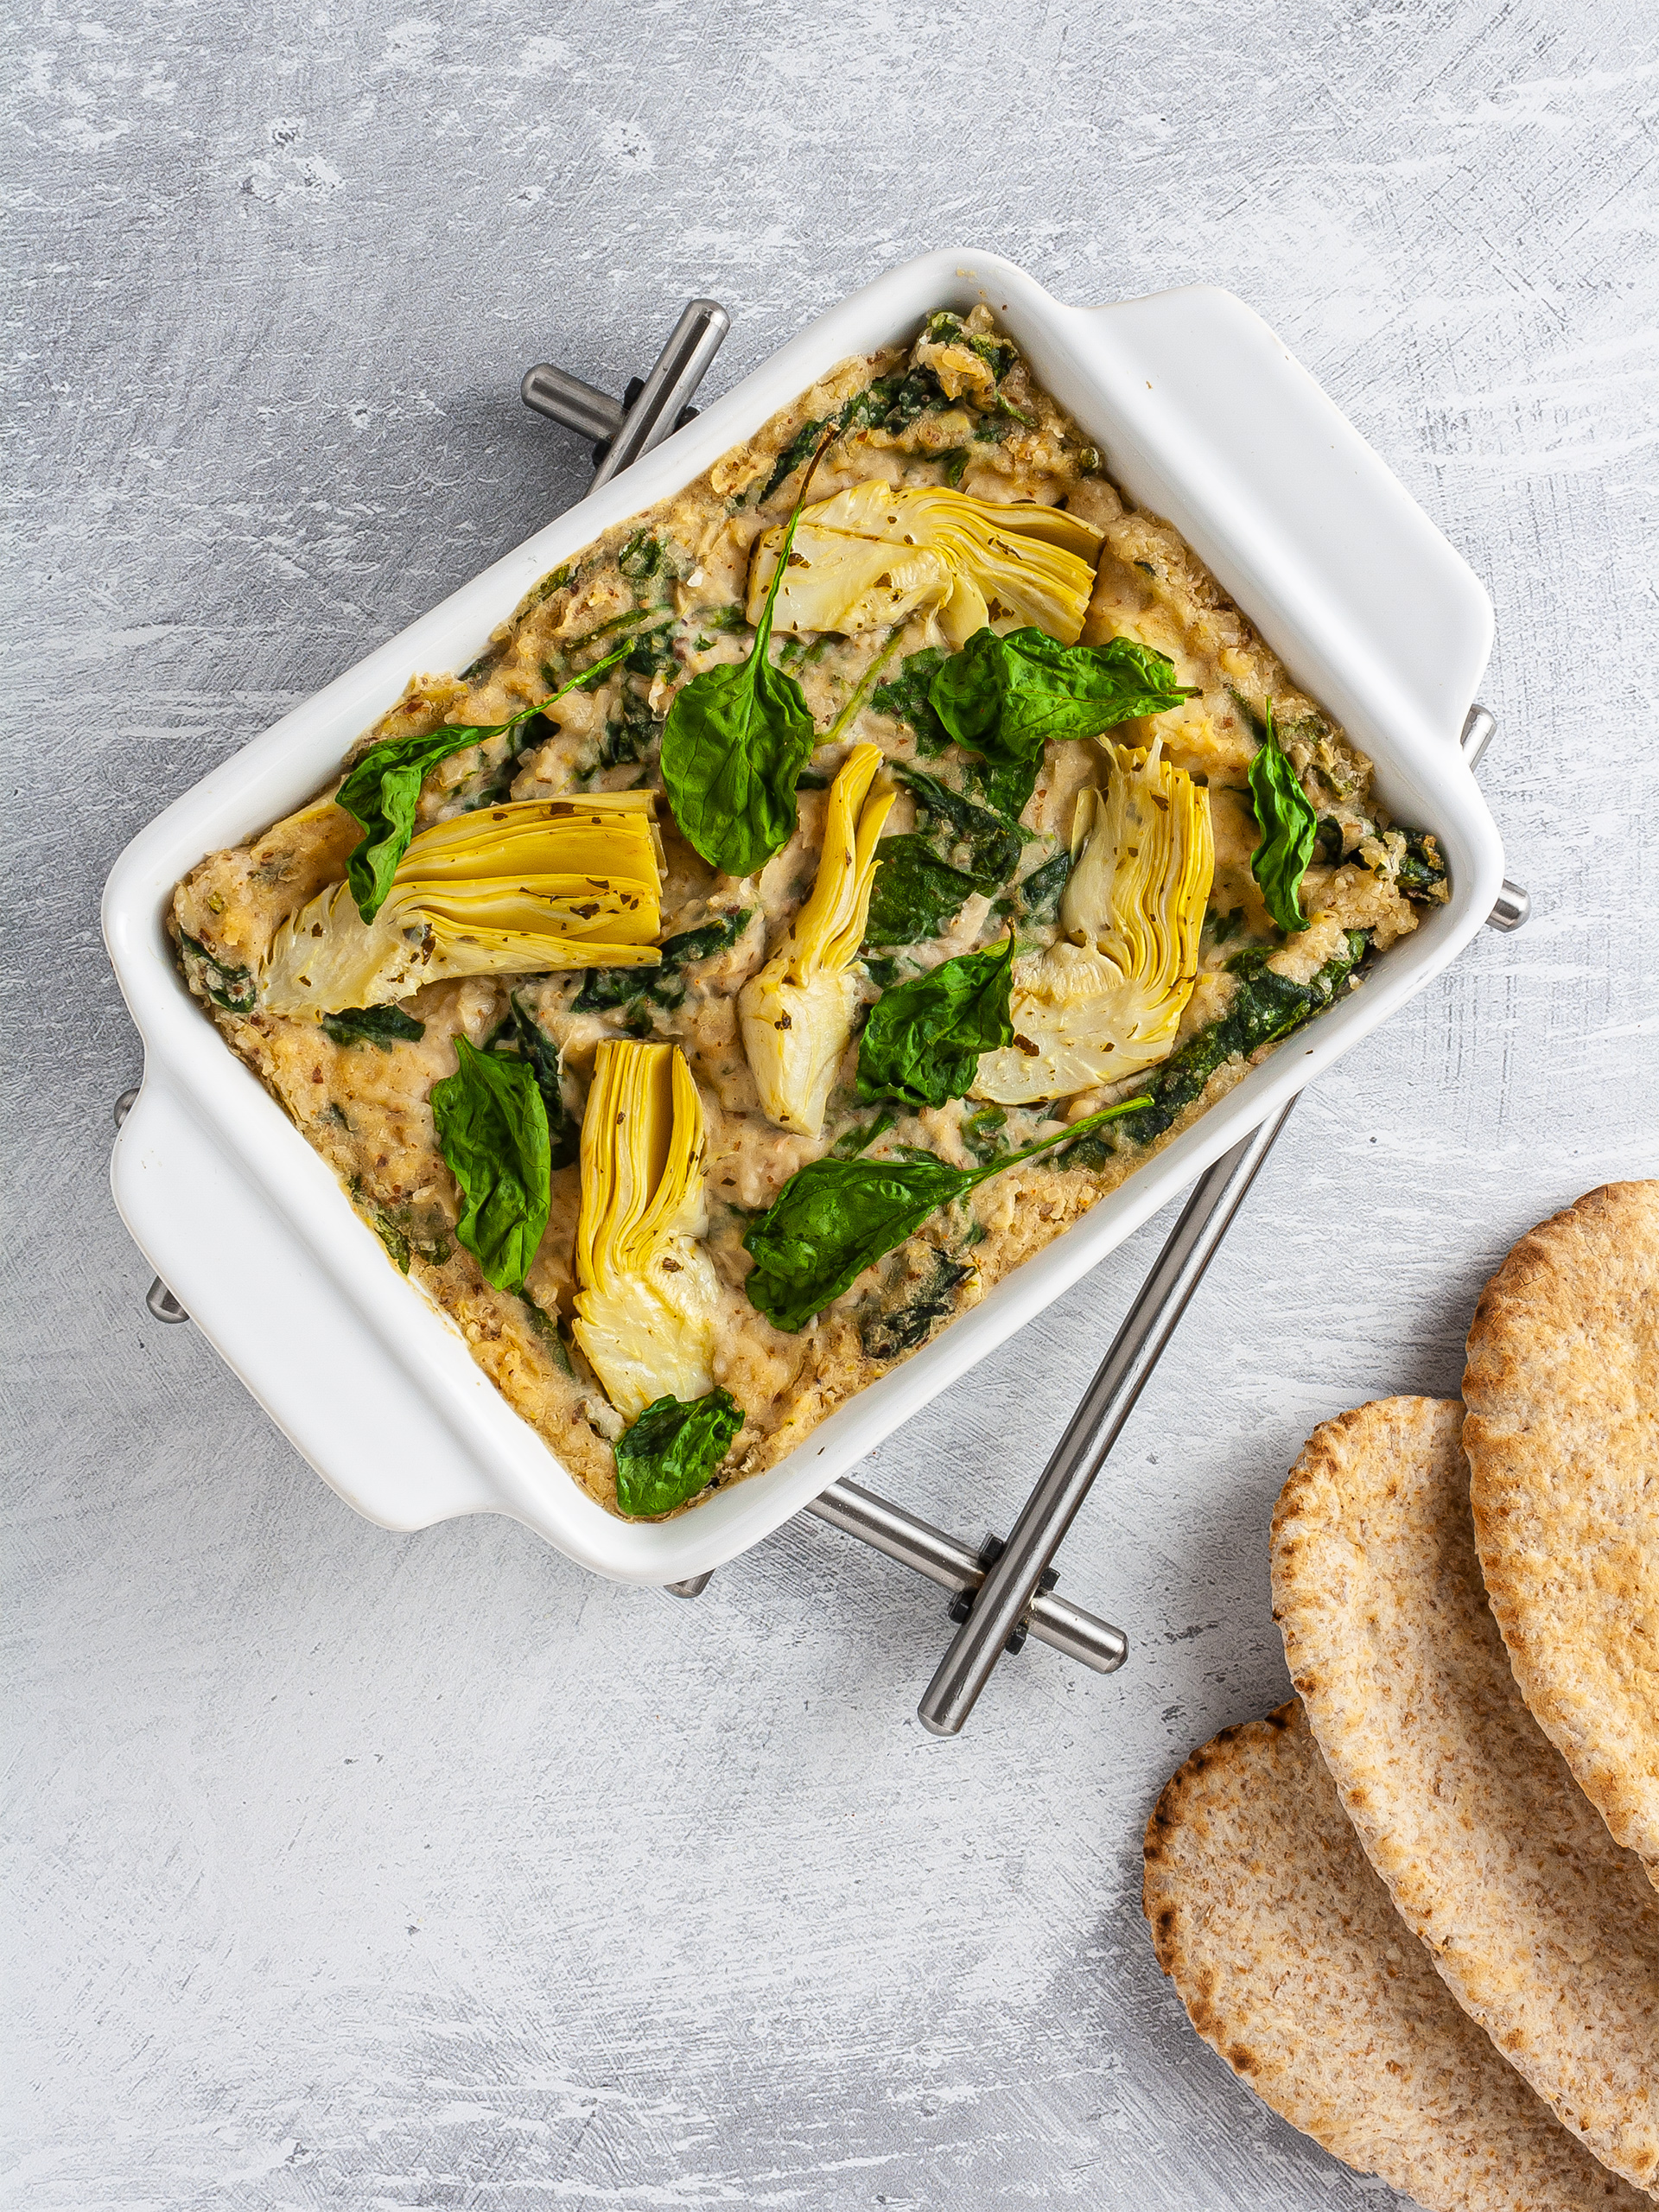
1462;1184;1659;1887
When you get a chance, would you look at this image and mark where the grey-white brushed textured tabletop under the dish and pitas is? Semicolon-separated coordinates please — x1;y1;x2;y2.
4;0;1659;2212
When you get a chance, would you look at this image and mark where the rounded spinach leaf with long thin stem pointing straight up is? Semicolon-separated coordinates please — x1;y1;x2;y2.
661;469;818;876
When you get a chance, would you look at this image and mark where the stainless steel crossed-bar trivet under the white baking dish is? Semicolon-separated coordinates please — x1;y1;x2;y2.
115;299;1531;1737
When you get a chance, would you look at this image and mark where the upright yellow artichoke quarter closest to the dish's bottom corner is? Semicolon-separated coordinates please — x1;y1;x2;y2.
573;1039;721;1421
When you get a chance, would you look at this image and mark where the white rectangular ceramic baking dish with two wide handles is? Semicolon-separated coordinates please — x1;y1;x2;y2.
104;250;1502;1584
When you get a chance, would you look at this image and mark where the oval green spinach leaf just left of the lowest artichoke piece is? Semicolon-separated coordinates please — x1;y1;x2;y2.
431;1038;553;1292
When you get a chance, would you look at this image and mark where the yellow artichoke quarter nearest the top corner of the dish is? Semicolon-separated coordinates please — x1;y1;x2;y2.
747;480;1102;646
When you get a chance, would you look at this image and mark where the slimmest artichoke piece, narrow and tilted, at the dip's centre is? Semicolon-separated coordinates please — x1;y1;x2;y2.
736;746;898;1137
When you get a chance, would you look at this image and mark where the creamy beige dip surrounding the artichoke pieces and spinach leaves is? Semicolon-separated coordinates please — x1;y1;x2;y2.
173;309;1445;1509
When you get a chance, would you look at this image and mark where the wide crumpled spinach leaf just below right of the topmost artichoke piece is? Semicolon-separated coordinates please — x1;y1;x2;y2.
927;628;1197;814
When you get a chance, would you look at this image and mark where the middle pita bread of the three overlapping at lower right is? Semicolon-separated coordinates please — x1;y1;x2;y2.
1272;1398;1659;2188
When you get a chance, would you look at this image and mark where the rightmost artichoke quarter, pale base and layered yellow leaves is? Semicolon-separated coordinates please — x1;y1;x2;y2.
973;746;1214;1106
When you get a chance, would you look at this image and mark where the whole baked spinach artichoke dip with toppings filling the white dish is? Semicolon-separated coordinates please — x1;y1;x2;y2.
173;308;1446;1516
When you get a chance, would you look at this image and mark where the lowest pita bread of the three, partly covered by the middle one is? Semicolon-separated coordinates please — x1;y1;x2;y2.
1141;1703;1648;2212
